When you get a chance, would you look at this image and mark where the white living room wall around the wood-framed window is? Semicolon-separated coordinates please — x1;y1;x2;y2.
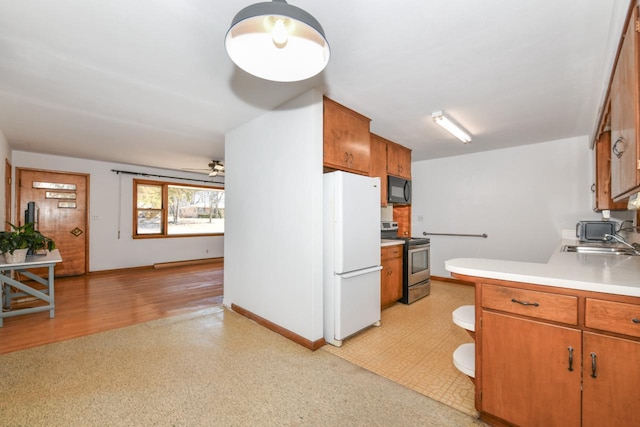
12;151;224;271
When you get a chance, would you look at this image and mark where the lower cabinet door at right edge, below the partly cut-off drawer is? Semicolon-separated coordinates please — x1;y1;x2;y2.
582;332;640;427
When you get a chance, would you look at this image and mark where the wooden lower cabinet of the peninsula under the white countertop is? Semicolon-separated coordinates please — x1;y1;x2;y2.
452;273;640;427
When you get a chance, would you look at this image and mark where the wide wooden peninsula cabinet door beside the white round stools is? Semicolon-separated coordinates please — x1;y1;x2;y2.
480;310;584;427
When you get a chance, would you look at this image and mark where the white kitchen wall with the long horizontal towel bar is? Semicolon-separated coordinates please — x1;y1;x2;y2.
411;136;601;277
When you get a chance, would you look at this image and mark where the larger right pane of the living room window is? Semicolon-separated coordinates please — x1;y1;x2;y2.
168;185;224;235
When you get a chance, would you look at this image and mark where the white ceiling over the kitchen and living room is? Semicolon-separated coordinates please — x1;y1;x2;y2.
0;0;629;174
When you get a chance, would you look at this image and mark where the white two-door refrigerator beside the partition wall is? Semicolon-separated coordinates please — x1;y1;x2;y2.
323;172;382;346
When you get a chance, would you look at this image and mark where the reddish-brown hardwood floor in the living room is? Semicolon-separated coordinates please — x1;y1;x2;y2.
0;262;223;354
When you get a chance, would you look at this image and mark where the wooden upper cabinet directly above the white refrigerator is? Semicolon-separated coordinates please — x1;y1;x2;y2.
324;97;371;175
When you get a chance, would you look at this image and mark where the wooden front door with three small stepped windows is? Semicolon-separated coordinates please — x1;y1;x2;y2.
15;168;89;276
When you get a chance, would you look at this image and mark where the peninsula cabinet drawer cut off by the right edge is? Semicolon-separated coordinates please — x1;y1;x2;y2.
584;298;640;338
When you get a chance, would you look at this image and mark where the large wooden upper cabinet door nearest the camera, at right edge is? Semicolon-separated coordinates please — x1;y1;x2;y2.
610;6;640;199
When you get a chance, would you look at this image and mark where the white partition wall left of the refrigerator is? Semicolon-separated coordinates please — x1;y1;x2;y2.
224;91;323;341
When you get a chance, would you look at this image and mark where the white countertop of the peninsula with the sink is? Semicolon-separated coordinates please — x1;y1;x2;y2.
444;240;640;297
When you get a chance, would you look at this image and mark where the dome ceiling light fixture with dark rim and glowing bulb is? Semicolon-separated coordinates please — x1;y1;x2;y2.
225;0;331;82
